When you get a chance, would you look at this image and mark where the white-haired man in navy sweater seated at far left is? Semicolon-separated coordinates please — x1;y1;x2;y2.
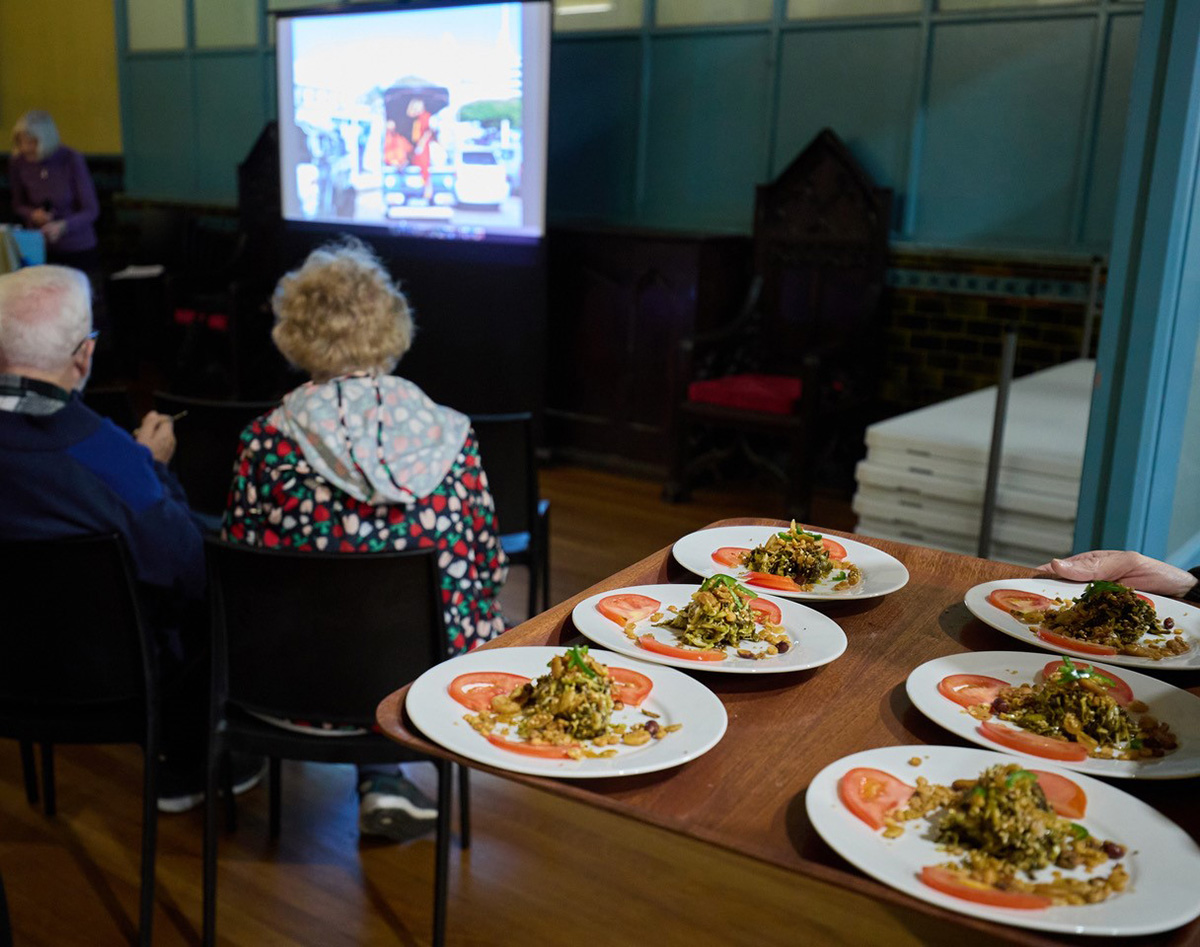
0;266;259;811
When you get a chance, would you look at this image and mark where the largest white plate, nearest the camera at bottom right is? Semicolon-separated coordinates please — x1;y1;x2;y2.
805;747;1200;936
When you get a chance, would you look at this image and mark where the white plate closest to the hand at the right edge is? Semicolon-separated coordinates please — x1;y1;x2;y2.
962;579;1200;671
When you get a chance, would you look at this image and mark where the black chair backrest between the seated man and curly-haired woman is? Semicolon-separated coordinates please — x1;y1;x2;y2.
154;391;278;515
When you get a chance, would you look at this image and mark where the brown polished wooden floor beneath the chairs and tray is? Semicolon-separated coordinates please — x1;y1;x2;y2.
0;468;964;947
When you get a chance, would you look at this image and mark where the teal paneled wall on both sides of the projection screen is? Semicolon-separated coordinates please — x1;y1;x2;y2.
114;0;1141;252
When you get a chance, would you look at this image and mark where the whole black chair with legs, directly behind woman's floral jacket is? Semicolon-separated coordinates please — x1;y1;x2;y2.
204;539;470;945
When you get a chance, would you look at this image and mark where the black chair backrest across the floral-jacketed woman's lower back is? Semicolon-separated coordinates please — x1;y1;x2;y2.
208;538;451;727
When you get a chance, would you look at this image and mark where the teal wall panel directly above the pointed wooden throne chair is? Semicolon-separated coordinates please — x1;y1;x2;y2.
770;26;920;220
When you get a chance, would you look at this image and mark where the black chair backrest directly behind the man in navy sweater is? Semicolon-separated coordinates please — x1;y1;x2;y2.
0;535;155;712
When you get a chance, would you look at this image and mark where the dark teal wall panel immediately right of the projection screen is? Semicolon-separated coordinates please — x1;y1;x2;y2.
546;36;642;223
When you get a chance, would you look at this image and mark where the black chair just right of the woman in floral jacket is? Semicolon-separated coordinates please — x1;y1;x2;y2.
470;412;550;618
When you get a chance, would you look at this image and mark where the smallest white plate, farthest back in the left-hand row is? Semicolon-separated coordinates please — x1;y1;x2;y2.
671;526;908;601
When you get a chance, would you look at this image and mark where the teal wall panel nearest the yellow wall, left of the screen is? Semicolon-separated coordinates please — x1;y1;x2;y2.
121;55;196;200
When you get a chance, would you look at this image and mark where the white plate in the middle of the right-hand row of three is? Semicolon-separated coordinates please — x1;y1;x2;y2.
906;651;1200;779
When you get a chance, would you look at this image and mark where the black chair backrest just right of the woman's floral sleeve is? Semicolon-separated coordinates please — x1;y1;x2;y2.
470;412;538;535
